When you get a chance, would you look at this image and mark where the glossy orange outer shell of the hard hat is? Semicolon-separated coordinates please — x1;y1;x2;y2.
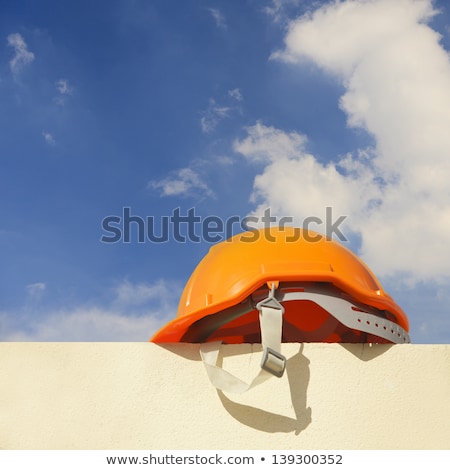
151;227;409;343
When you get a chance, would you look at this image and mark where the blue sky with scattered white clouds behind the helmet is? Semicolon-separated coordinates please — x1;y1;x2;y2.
0;0;450;343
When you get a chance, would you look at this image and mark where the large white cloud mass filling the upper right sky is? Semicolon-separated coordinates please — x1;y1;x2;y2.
239;0;450;281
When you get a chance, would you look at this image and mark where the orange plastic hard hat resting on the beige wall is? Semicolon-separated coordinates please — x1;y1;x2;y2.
151;227;409;343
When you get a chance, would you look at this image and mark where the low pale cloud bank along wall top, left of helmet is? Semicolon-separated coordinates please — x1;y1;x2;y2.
0;280;179;341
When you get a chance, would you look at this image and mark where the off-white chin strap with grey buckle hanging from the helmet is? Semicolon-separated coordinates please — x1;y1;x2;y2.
200;282;286;393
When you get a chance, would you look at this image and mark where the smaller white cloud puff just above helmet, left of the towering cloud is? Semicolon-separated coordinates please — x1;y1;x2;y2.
234;123;379;231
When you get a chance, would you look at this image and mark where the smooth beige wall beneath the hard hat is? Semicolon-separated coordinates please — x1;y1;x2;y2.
0;343;450;450
